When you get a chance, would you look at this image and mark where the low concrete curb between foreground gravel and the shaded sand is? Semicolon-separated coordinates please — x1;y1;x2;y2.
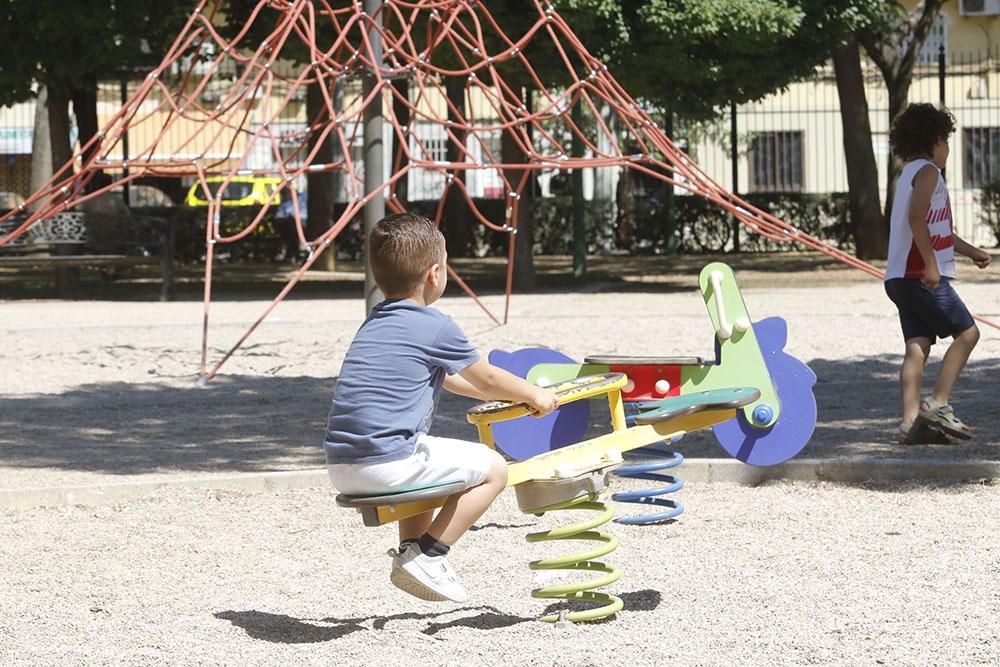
0;458;1000;509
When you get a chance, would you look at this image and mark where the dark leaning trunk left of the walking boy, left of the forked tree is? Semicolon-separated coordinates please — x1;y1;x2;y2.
833;40;888;259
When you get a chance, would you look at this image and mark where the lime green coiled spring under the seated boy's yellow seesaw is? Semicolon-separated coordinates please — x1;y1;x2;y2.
527;494;623;623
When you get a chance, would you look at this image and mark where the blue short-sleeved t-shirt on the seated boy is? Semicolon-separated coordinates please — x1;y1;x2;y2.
323;299;479;464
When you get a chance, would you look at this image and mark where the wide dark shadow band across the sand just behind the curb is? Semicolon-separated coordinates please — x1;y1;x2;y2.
0;355;1000;477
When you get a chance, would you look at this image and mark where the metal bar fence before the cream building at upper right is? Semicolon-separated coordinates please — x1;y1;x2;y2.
684;47;1000;247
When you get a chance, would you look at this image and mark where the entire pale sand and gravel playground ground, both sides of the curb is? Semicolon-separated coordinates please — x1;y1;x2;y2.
0;253;1000;665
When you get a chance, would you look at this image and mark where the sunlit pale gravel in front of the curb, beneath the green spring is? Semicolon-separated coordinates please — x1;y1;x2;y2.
0;482;1000;667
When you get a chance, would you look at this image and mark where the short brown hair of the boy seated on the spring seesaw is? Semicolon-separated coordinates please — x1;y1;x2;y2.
368;213;444;296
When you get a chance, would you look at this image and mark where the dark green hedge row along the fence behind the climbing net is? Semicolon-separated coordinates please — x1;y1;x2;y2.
172;187;856;262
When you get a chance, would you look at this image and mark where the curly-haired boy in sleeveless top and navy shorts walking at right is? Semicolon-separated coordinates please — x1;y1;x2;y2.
885;104;991;444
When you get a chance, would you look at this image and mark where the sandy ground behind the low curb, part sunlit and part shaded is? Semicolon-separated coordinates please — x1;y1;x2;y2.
0;254;1000;505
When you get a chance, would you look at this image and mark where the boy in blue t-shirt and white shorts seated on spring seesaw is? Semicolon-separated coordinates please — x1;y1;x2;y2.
324;213;558;602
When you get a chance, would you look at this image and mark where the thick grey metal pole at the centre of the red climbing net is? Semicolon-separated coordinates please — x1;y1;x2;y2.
363;0;385;314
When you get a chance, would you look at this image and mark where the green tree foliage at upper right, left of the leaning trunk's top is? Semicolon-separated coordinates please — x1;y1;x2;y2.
606;0;871;118
